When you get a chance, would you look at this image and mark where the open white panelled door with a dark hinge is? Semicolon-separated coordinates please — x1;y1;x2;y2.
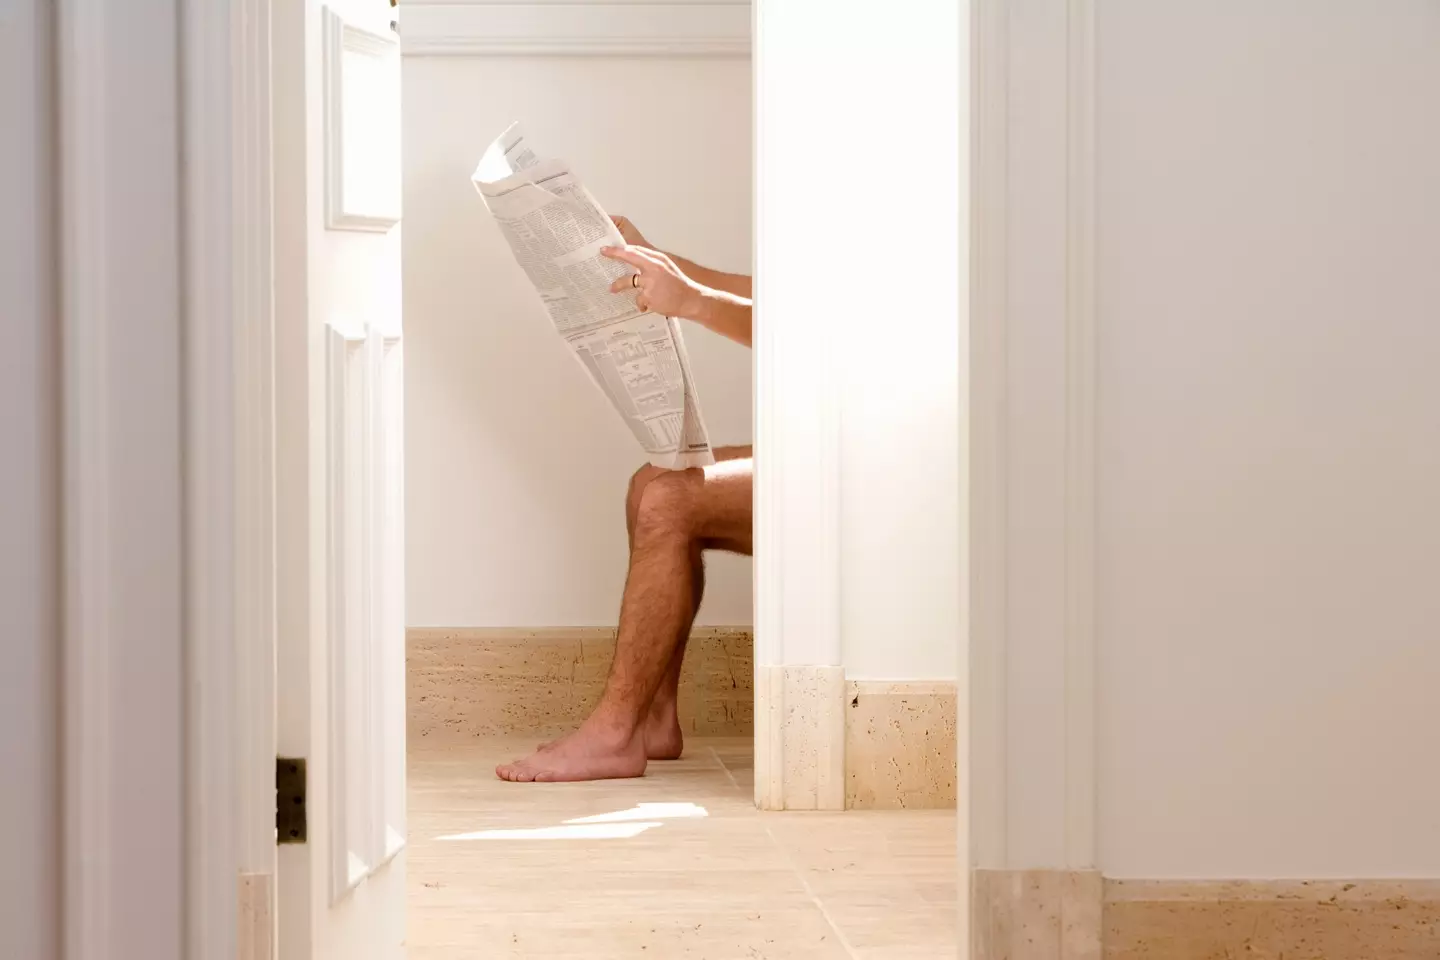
272;0;405;960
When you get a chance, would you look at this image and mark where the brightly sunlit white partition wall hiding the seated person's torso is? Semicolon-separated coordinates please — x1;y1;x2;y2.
757;3;962;679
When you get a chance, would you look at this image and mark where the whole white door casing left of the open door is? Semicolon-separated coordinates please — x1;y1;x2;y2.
52;0;244;960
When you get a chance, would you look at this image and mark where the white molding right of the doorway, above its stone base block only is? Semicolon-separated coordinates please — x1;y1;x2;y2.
962;0;1097;874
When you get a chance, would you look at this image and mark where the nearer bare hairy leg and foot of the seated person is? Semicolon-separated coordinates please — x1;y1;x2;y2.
495;459;753;782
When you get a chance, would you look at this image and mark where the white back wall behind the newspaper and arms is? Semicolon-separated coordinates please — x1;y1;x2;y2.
405;56;752;626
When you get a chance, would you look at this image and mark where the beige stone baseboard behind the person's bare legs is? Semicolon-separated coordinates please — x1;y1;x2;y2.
406;628;755;741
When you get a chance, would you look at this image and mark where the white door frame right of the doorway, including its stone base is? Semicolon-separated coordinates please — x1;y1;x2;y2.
959;0;1103;956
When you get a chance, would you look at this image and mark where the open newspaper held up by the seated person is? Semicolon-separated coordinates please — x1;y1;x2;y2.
472;124;714;469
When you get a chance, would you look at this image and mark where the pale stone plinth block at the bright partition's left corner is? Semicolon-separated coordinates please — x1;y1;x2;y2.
755;665;845;810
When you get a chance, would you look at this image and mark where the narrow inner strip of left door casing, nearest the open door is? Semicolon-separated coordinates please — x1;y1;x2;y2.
177;0;241;957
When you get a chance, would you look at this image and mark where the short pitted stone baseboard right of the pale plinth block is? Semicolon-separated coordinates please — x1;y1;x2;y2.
845;681;956;810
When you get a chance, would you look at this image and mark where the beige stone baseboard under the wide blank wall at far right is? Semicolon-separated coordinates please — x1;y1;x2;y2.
1104;879;1440;960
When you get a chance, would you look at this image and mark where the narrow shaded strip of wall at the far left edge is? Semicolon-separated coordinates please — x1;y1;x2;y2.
0;0;60;957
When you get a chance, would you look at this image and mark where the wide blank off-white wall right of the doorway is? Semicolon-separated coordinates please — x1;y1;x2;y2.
1099;0;1440;877
